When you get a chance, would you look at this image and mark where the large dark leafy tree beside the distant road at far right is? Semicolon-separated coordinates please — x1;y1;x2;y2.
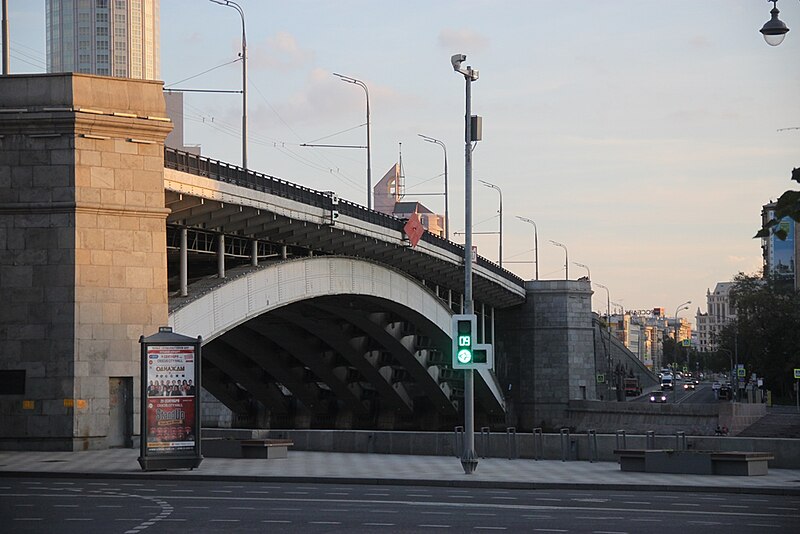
720;273;800;400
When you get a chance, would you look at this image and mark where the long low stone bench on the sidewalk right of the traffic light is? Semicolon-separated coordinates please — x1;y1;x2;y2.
614;449;775;476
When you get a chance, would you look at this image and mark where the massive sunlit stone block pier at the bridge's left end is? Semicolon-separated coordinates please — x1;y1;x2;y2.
0;73;171;450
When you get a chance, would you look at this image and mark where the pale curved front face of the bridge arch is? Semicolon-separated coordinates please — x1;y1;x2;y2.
169;256;452;343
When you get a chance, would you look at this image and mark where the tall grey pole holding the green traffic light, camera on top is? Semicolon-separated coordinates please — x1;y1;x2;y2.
450;54;478;475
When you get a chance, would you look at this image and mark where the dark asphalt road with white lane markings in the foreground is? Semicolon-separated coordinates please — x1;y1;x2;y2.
0;478;800;534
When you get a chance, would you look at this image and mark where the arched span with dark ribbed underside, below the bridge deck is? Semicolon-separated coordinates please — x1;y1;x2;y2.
170;256;503;429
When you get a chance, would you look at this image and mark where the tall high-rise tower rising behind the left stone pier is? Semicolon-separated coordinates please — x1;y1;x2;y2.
45;0;160;80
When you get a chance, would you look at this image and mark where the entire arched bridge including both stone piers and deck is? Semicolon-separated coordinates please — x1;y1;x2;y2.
0;73;652;450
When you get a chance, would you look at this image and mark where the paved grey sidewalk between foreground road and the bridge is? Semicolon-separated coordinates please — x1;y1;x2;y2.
0;449;800;495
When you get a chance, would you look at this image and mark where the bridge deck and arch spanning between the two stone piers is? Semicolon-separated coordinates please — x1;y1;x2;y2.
164;148;525;429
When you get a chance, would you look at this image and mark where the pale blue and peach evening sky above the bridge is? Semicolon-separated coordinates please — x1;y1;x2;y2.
9;0;800;322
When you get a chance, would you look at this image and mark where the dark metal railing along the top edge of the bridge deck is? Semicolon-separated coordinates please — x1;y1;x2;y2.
164;147;523;285
